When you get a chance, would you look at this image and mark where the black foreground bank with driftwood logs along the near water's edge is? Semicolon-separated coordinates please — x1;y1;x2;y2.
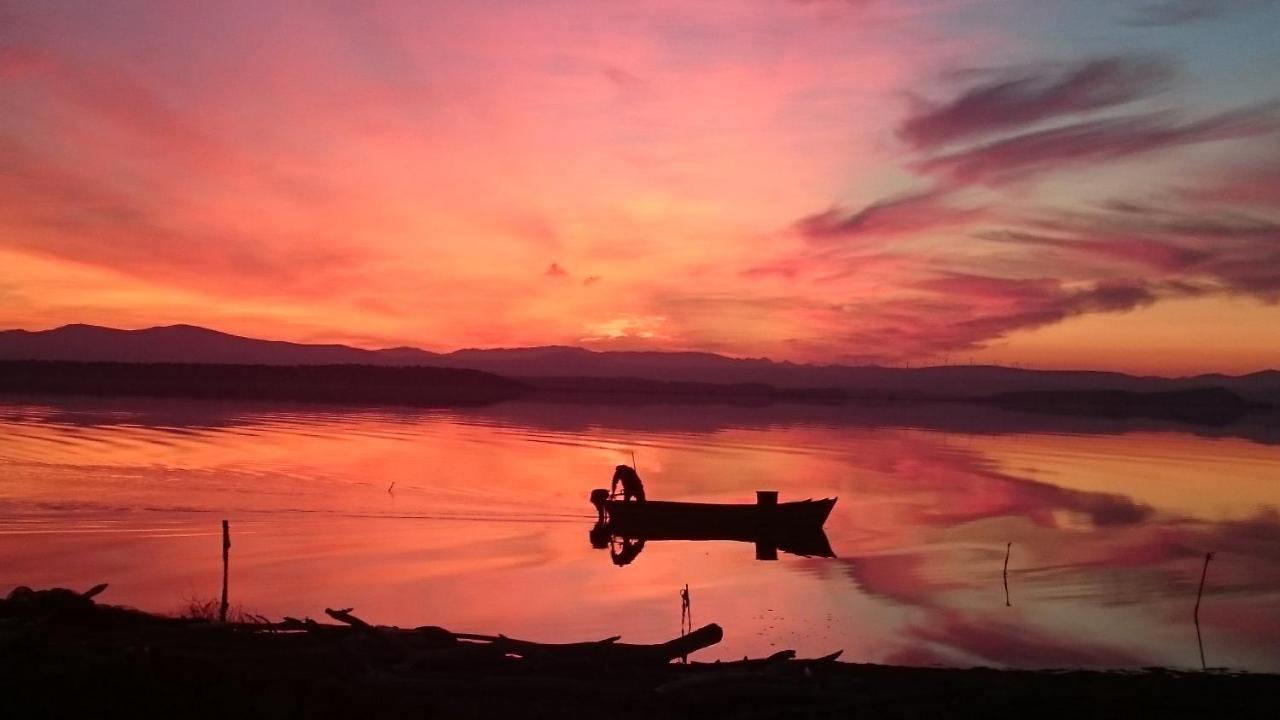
0;589;1280;719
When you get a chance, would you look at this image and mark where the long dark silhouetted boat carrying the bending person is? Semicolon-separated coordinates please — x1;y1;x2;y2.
591;489;836;537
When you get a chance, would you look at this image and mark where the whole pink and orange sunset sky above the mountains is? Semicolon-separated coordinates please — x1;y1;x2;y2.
0;0;1280;374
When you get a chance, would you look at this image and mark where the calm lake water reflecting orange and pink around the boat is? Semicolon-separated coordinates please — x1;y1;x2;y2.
0;400;1280;671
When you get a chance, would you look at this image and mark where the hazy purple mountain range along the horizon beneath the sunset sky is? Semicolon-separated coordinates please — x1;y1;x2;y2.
0;324;1280;404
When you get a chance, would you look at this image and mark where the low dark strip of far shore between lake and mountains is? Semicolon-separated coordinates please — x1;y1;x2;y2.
0;360;1280;425
